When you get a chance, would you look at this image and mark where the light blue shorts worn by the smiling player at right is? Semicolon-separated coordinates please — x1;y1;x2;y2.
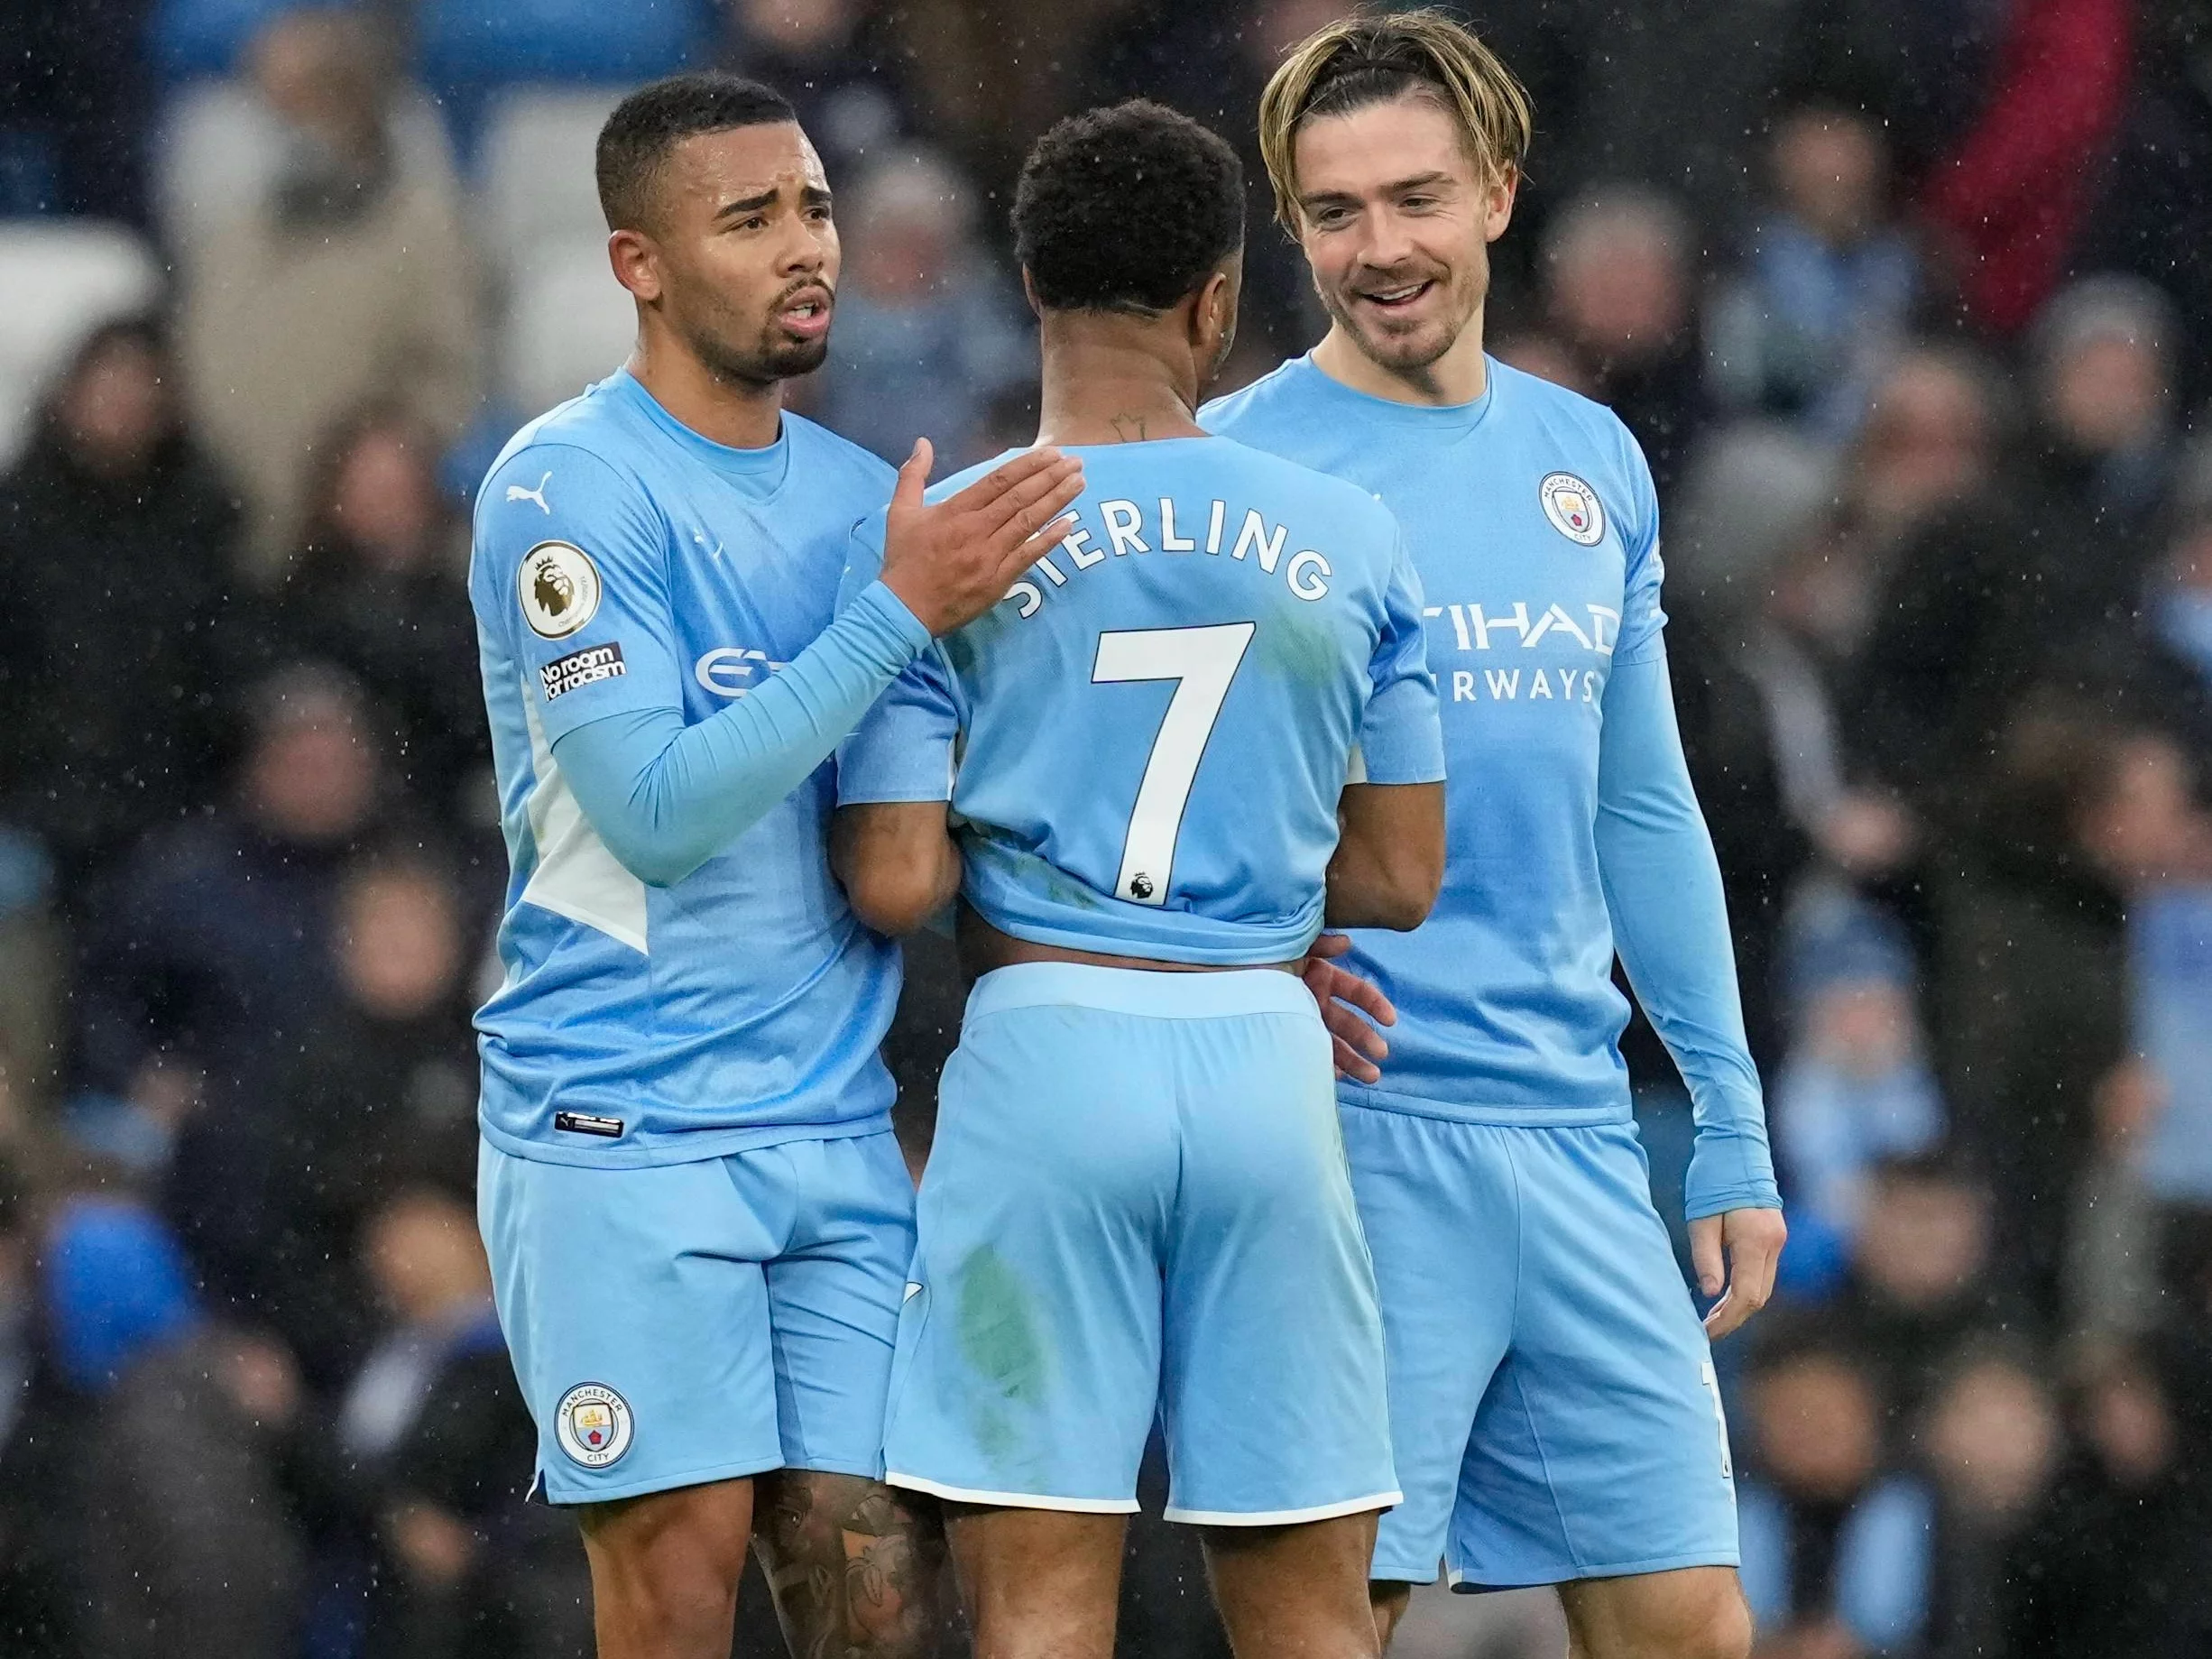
1342;1104;1737;1590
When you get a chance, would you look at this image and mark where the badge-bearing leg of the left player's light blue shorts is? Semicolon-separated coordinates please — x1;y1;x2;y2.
478;1146;783;1504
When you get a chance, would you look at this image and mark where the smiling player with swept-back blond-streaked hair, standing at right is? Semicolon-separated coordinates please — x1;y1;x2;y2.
1201;11;1783;1659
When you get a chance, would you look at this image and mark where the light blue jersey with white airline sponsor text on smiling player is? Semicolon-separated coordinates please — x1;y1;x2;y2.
1199;358;1665;1124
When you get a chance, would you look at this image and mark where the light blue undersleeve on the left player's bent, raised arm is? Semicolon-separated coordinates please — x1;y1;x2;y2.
553;586;929;887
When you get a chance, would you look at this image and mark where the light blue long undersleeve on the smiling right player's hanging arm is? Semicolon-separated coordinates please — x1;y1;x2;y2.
1597;657;1781;1219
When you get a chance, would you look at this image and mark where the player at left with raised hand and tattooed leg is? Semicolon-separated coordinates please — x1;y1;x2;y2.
471;75;1080;1659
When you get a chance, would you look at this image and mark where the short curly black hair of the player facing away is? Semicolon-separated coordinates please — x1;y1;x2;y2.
1013;97;1245;317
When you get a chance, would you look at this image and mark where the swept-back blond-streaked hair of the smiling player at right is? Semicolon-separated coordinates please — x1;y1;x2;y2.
1258;6;1535;230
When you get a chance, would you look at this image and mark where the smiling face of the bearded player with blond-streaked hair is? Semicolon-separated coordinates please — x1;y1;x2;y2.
1294;93;1516;378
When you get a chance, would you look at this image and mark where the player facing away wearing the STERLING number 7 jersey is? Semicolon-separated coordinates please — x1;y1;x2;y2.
832;102;1444;1659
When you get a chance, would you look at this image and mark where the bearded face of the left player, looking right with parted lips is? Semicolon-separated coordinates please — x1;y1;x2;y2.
611;122;838;385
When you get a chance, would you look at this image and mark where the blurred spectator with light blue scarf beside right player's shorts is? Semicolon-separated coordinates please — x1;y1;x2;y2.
1737;1332;1933;1659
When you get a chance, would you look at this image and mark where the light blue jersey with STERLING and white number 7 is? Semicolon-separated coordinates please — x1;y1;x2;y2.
838;438;1444;964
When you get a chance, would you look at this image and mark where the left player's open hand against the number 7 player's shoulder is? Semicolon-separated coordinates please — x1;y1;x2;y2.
882;438;1083;635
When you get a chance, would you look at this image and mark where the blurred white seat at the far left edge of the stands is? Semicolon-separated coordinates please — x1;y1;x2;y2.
0;219;162;465
